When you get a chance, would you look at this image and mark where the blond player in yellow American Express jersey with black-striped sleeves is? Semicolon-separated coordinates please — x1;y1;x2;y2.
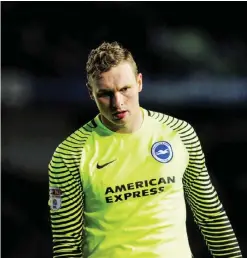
49;42;242;258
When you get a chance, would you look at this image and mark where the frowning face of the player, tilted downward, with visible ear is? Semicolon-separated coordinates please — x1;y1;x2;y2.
89;62;142;130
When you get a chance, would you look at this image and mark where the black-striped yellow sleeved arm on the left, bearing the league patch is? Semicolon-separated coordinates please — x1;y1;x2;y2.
49;146;83;258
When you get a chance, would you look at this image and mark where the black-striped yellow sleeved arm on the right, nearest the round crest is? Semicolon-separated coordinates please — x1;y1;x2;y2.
181;125;242;258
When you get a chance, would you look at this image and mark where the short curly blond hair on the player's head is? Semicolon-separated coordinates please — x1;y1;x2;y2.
86;41;138;87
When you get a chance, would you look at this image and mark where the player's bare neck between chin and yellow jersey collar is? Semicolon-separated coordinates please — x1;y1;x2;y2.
100;108;144;134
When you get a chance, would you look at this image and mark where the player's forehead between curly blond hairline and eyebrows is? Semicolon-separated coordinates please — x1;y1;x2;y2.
95;62;136;89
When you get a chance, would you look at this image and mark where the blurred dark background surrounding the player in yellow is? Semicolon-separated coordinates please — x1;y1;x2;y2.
1;1;247;258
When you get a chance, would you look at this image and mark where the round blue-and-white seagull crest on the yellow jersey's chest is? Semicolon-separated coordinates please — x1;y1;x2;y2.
151;141;173;163
